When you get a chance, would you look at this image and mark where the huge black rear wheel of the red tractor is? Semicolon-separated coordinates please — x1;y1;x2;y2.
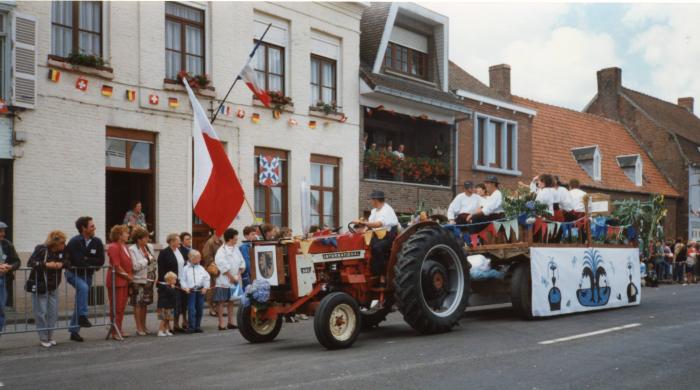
394;228;469;334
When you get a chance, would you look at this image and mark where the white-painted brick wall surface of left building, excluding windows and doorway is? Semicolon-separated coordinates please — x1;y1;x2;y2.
14;2;362;251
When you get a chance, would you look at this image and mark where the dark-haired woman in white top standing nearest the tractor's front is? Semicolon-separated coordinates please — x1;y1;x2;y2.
213;228;245;330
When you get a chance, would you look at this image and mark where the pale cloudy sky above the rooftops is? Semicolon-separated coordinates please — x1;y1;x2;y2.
419;2;700;113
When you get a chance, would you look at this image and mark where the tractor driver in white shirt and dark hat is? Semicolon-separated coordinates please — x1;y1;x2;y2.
353;191;399;286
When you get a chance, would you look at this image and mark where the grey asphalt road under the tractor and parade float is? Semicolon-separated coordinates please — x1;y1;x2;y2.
0;285;700;390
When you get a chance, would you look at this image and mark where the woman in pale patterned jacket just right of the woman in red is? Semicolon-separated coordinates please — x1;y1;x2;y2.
129;226;156;336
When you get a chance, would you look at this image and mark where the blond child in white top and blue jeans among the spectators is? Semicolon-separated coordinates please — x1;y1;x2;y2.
180;249;211;334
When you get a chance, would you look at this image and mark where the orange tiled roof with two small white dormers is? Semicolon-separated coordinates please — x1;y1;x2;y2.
513;96;678;197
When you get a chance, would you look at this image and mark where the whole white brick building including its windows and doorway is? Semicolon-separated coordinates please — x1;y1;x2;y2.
3;2;364;251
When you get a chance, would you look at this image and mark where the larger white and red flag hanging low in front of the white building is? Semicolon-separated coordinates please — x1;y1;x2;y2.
183;78;245;235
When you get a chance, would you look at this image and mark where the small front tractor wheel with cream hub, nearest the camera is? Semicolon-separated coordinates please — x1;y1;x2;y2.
314;292;362;349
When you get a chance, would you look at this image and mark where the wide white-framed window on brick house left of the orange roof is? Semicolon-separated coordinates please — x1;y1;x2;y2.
472;113;522;176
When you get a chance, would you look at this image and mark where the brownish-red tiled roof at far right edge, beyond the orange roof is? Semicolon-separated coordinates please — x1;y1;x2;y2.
622;87;700;144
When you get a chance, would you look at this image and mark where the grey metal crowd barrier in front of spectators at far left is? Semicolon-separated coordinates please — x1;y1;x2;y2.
0;266;114;335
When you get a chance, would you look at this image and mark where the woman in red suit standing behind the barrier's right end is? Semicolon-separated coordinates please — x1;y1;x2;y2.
106;225;134;341
